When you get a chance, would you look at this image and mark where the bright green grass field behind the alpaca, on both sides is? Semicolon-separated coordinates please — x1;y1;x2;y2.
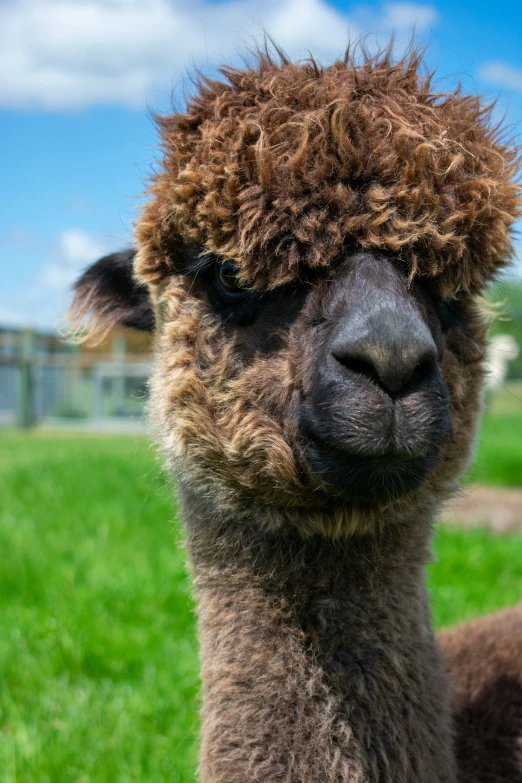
0;402;522;783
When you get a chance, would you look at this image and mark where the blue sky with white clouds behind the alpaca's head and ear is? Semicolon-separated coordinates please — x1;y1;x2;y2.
0;0;522;328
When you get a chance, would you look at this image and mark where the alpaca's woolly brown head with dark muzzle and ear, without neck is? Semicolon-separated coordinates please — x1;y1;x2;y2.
71;50;521;535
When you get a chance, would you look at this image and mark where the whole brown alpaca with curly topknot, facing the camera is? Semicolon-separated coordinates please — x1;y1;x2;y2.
73;52;522;783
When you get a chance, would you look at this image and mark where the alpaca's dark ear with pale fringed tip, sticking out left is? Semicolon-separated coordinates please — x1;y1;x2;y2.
68;249;154;342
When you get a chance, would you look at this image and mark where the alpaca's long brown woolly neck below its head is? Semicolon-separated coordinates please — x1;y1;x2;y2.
185;494;456;783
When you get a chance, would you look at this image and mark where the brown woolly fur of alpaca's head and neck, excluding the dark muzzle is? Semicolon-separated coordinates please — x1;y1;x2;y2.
70;44;522;783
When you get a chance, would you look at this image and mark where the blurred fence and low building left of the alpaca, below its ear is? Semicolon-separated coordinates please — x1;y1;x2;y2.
0;330;152;431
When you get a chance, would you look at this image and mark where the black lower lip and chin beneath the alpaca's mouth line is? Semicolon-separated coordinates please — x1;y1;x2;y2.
296;436;440;505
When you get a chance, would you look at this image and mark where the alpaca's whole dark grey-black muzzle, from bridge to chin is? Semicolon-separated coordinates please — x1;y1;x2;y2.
299;254;451;503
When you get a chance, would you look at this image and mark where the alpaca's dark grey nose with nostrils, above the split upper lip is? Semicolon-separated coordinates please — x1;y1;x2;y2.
330;307;437;397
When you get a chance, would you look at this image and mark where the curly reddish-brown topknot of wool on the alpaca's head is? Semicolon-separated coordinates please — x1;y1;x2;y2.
138;47;522;296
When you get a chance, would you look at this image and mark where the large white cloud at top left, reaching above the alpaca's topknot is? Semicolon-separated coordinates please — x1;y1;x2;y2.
0;0;358;109
